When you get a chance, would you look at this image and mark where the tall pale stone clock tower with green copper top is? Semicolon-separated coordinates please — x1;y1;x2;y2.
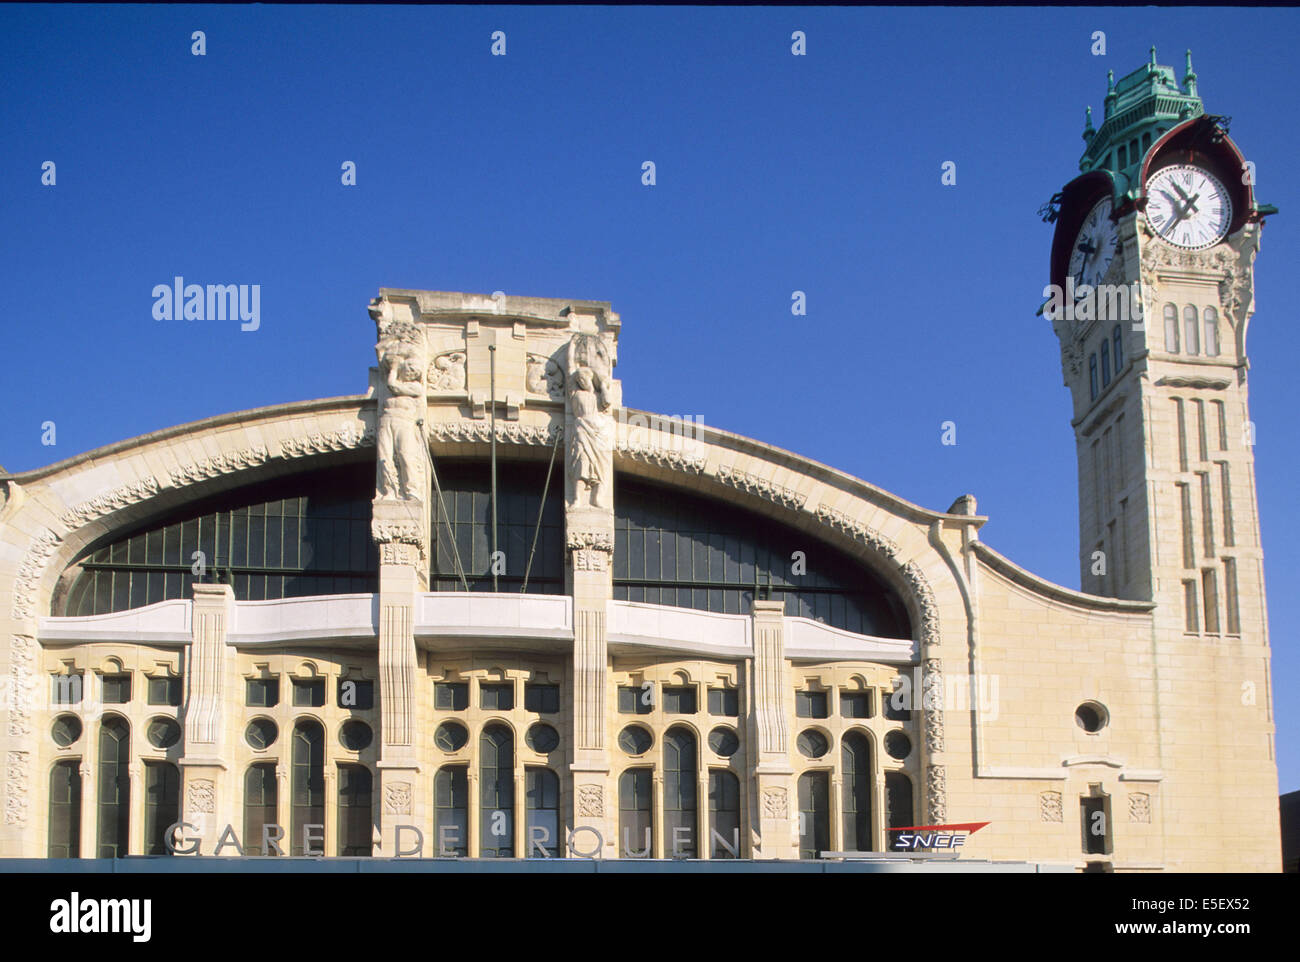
1045;48;1277;863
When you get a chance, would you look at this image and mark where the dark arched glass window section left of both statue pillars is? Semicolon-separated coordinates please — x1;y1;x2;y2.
61;462;378;615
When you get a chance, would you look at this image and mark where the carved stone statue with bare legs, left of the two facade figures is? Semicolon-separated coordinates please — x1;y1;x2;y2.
369;298;429;502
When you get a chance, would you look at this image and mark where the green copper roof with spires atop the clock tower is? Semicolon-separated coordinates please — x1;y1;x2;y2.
1079;47;1205;193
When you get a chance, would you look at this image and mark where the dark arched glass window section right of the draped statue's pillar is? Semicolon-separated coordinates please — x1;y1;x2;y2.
614;476;911;638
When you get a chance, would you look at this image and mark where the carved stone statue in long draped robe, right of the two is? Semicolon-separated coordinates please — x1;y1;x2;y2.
567;334;614;510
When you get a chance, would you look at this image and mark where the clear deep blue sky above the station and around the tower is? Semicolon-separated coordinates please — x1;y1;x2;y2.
0;5;1300;790
